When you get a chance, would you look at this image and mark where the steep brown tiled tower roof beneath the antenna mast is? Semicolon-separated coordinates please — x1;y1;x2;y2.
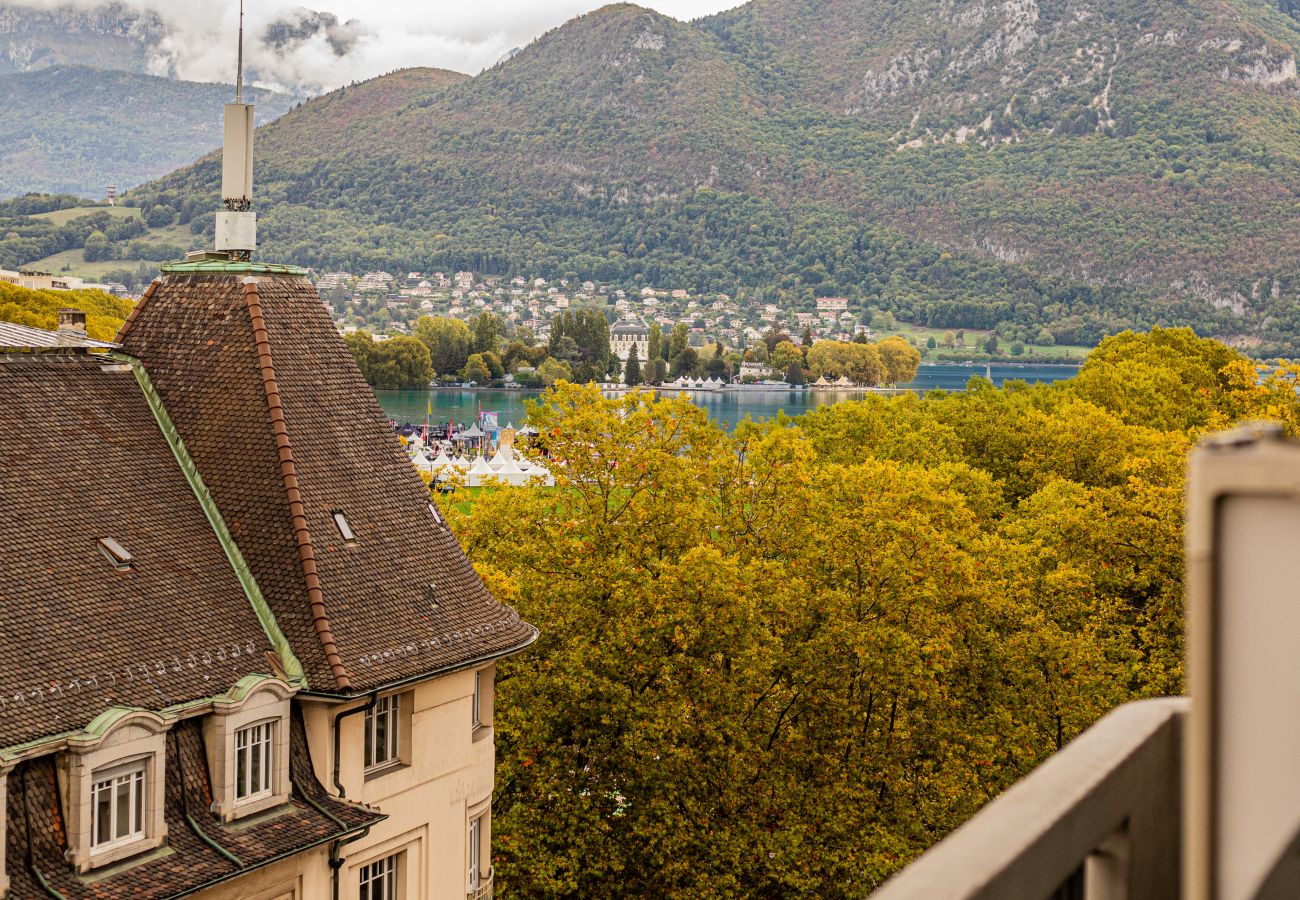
118;273;536;692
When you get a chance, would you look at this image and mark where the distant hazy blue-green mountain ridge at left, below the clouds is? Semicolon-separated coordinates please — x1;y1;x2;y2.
0;66;296;198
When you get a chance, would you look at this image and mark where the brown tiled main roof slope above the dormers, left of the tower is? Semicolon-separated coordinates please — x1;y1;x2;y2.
0;352;272;747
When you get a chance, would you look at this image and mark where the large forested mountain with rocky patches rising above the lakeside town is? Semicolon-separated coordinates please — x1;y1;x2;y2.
122;0;1300;352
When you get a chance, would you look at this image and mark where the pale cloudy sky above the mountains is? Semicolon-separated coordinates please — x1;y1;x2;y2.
25;0;740;94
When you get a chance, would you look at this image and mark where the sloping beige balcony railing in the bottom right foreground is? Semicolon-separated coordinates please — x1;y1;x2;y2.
874;697;1188;900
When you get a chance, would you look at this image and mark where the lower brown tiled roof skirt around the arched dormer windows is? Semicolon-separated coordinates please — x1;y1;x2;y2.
5;711;384;900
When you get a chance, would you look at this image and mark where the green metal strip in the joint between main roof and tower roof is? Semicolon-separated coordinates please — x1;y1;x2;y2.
107;348;307;687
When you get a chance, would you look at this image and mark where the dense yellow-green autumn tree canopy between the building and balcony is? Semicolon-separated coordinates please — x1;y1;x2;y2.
452;329;1300;899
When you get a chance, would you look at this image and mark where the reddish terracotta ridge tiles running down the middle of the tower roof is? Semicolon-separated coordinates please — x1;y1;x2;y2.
243;278;352;691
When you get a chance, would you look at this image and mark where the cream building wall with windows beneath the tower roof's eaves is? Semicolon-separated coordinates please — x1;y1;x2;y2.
299;666;495;900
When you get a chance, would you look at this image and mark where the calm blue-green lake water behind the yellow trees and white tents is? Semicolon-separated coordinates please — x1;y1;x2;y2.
374;365;1079;428
